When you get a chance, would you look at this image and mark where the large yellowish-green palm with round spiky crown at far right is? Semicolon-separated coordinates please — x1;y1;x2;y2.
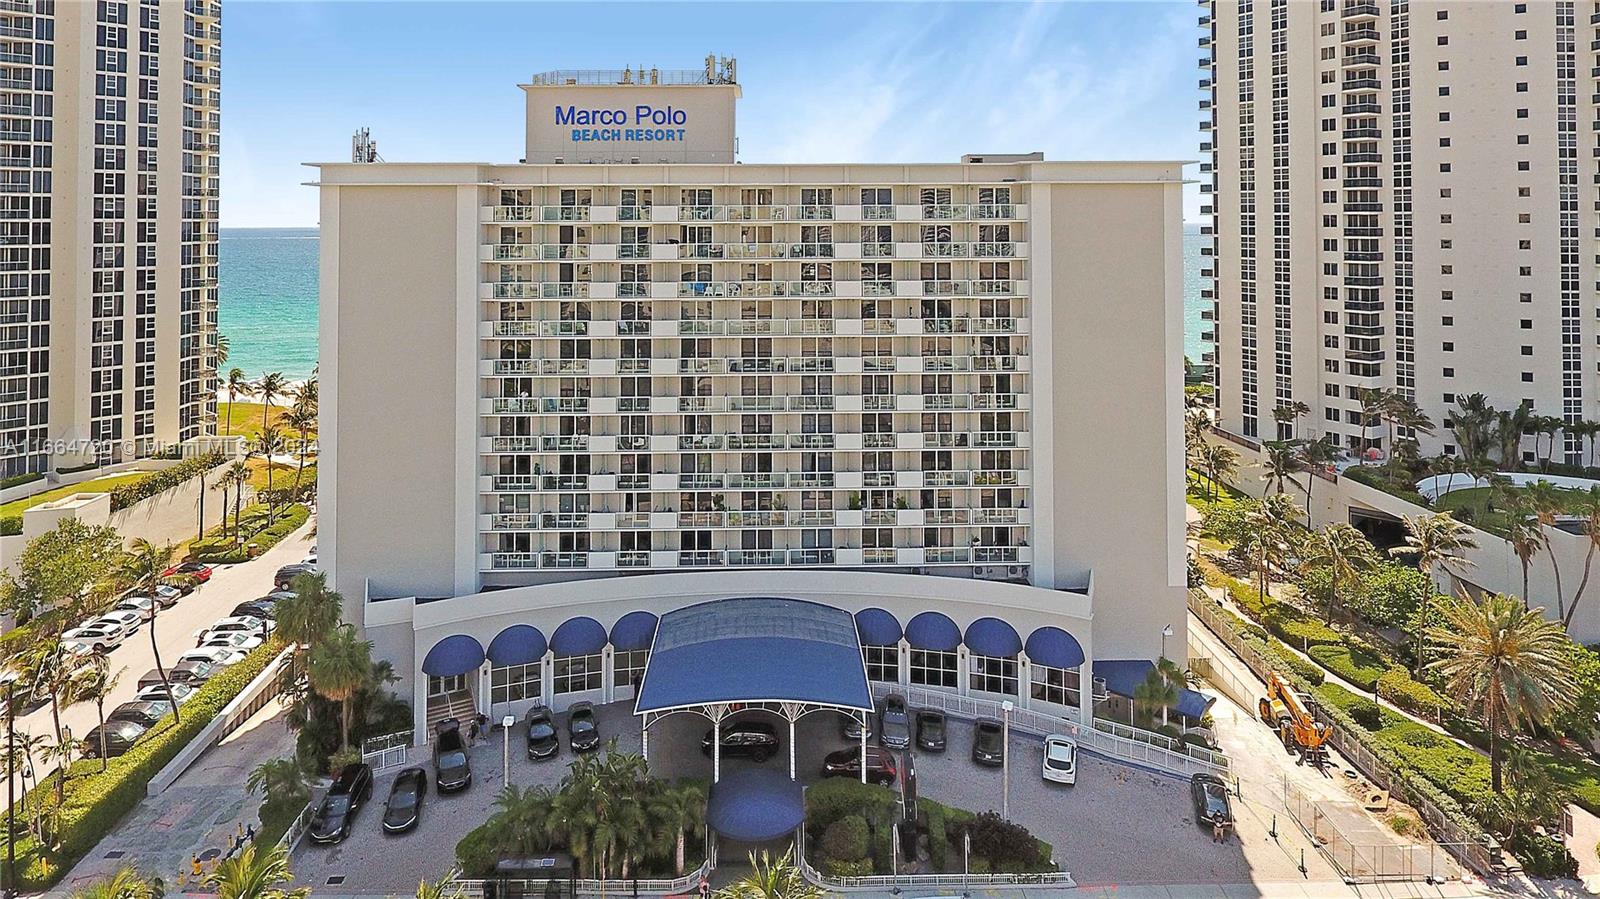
1429;593;1578;793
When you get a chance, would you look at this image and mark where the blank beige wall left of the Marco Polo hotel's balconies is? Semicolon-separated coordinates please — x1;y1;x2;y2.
322;187;470;598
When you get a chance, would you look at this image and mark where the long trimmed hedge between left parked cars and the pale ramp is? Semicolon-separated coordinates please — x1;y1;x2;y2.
16;638;283;891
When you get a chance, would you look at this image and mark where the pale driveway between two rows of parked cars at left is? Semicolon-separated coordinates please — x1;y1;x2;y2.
0;518;315;809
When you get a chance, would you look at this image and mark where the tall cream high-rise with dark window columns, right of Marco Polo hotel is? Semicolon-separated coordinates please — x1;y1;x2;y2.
1200;0;1600;461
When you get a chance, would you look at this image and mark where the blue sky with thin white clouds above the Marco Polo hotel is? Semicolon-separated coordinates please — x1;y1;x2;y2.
222;0;1200;227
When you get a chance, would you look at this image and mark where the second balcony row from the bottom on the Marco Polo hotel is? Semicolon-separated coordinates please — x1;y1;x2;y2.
478;507;1034;531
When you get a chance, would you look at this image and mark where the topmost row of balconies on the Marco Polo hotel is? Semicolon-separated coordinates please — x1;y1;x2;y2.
482;203;1027;224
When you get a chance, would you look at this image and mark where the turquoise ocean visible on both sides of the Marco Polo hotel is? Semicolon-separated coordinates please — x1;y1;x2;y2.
218;224;1205;379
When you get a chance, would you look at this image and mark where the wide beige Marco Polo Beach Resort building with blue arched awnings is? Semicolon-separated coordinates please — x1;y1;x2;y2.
318;59;1186;734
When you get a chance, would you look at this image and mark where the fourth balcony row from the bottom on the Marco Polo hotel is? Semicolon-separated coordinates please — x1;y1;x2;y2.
478;430;1032;454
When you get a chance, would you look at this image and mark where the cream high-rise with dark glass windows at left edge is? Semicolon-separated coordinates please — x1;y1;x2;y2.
0;0;221;477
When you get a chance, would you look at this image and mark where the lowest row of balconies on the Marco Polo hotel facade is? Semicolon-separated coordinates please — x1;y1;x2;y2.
478;545;1034;571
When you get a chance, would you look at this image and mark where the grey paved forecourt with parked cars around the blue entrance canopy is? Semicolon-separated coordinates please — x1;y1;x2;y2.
293;702;1330;894
